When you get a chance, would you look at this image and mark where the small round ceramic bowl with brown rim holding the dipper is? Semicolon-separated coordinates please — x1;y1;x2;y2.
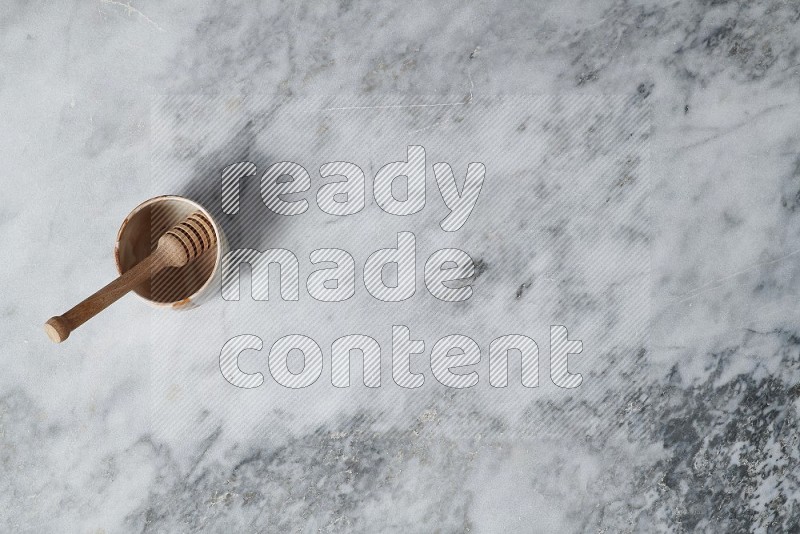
114;196;227;310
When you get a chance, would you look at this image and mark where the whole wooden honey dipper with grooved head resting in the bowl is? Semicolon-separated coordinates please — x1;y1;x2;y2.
44;211;217;343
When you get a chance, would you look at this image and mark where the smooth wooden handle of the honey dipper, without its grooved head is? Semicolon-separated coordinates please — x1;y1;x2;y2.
44;250;166;343
